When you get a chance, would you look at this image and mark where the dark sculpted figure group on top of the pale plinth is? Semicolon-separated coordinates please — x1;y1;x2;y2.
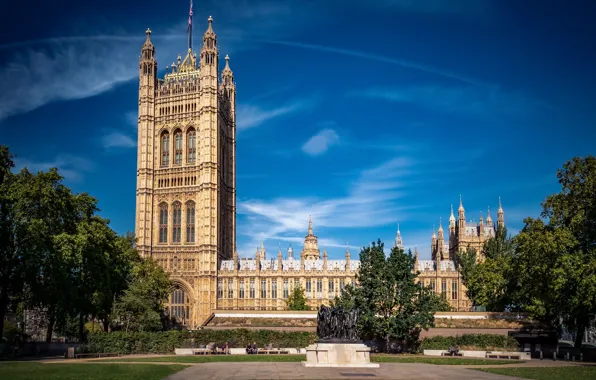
317;305;360;343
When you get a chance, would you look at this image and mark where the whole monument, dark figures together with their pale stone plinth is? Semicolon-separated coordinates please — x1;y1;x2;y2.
302;306;379;368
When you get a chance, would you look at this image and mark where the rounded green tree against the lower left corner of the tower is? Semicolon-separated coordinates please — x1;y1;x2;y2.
114;259;172;331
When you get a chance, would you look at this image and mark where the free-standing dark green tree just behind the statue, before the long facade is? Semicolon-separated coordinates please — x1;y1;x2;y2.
335;240;449;350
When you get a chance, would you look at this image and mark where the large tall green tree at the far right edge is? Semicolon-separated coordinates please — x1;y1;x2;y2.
516;156;596;348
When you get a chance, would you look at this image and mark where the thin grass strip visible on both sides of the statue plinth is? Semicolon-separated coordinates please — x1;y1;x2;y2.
105;355;522;365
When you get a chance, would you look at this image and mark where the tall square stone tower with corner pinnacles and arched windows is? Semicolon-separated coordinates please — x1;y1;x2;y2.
136;16;236;329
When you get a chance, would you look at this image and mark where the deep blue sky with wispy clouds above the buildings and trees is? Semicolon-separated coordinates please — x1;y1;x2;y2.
0;0;596;258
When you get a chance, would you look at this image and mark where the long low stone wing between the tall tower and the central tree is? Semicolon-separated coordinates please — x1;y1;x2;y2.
217;219;360;310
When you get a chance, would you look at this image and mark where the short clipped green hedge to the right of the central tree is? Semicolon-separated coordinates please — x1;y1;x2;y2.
419;334;519;351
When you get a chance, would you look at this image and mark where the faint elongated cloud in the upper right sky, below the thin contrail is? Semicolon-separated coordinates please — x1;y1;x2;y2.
348;85;546;118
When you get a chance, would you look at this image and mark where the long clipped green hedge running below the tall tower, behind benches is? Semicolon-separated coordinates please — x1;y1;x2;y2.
80;329;316;355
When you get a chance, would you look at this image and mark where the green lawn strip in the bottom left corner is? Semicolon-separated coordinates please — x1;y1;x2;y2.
0;362;187;380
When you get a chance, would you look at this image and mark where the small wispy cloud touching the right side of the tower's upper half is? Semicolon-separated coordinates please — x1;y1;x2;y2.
236;99;314;130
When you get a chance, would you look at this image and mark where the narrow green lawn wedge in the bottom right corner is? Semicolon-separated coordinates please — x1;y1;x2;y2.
478;366;596;380
